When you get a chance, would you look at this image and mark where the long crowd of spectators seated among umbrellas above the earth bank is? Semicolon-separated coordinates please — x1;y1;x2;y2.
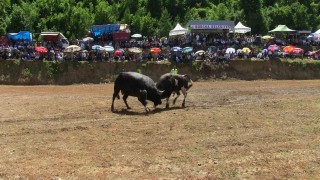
0;34;320;62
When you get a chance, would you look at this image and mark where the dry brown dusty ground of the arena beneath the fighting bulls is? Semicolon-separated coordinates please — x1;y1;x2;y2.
0;80;320;179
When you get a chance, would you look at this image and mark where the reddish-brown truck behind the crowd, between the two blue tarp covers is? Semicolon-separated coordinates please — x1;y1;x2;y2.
40;32;70;49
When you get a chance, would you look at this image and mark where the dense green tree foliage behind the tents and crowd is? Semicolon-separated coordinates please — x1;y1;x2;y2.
0;0;320;39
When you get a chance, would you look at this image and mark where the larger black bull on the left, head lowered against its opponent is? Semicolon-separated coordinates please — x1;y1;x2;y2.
111;72;162;113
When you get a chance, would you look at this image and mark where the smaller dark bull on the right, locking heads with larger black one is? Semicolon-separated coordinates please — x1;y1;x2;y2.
156;73;193;108
